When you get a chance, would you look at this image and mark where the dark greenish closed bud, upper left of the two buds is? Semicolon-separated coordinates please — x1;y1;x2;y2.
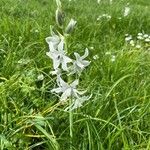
56;8;64;27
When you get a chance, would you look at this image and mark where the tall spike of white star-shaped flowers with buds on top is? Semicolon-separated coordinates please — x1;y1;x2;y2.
46;0;90;111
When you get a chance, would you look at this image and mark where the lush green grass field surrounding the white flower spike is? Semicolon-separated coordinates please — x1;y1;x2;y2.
0;0;150;150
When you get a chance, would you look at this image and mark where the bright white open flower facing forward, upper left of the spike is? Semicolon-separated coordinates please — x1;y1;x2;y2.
46;41;72;71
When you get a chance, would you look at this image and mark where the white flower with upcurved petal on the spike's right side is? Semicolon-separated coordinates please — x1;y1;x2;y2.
70;48;90;74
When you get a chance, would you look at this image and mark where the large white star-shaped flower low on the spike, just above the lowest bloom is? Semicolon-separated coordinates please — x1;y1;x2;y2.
51;77;85;101
